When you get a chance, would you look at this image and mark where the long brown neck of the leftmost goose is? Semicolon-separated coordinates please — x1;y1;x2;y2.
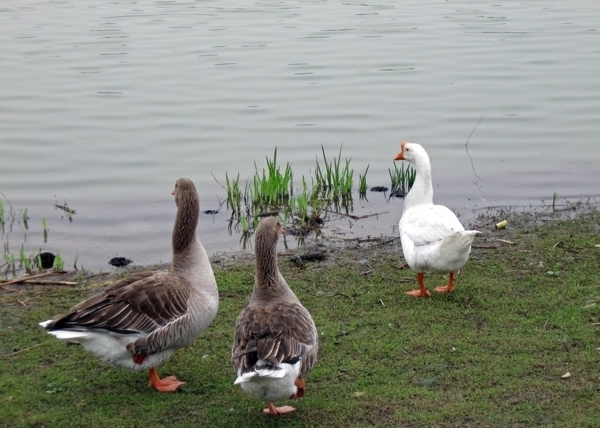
172;192;200;261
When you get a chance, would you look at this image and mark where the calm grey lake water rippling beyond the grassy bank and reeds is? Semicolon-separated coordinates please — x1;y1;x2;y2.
0;0;600;270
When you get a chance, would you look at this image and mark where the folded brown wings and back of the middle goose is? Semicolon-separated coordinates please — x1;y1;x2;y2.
231;303;317;377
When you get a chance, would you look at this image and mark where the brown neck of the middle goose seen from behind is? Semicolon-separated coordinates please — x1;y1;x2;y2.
252;237;293;300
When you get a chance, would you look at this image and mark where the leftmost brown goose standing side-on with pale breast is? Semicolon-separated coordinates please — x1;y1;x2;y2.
40;178;219;392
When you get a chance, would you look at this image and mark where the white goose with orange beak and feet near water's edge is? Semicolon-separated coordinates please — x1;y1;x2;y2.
394;141;480;297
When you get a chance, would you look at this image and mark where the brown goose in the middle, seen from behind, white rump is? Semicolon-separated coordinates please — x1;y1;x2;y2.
231;217;318;415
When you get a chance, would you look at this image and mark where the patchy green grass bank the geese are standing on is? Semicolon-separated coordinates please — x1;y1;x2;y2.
0;213;600;428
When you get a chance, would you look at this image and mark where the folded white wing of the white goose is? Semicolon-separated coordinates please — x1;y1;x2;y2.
400;205;465;247
